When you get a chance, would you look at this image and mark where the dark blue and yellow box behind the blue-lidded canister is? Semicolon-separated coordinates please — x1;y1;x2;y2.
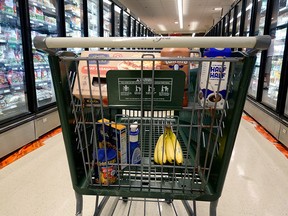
97;119;127;169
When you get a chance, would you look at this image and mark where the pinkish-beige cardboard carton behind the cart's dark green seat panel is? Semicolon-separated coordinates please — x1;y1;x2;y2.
73;51;161;105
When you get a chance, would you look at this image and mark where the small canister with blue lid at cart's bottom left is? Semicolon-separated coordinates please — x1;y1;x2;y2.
94;148;117;185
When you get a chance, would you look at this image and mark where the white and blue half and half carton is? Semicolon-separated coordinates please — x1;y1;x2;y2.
198;48;231;109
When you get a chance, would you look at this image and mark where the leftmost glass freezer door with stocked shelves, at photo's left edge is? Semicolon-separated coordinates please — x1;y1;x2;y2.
0;0;28;121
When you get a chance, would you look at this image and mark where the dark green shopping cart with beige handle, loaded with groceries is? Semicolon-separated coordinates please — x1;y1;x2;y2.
34;36;270;215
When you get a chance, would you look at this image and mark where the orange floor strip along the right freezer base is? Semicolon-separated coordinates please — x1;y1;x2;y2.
242;115;288;158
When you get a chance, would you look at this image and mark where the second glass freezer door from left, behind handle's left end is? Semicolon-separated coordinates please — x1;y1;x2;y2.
29;0;57;107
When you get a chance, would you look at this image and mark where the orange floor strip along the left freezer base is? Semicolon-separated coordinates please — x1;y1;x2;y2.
0;128;62;169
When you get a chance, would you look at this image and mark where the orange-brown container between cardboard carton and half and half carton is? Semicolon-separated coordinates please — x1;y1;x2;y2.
161;48;190;107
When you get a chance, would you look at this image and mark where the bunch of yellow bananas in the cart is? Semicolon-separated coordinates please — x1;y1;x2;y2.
154;125;183;165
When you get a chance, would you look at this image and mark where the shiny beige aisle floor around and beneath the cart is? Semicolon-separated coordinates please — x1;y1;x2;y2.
0;116;288;216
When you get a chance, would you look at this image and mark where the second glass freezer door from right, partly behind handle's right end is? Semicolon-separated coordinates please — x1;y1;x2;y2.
248;0;267;98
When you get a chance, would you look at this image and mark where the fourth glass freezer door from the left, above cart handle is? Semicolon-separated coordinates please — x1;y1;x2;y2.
87;0;100;37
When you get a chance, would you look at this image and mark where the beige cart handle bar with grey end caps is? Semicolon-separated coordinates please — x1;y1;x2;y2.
34;35;271;50
